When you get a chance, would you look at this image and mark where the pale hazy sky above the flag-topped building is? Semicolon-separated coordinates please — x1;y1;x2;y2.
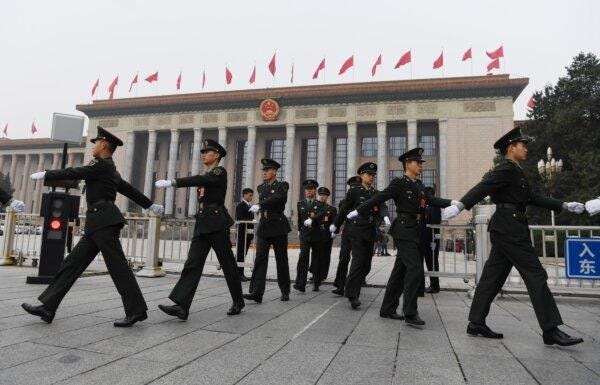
0;0;600;138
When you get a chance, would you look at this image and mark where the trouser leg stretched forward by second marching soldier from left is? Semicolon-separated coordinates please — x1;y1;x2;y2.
169;234;213;309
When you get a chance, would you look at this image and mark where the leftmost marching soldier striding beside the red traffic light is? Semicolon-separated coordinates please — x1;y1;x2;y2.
22;127;164;327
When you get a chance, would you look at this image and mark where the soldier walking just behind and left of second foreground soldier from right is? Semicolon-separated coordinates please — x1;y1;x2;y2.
330;162;390;309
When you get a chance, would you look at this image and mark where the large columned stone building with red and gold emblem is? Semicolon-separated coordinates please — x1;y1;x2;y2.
0;75;528;217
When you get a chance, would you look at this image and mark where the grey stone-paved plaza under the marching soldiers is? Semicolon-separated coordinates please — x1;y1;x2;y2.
0;267;600;385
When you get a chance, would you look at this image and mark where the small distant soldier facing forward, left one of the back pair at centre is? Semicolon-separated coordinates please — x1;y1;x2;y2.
294;179;325;293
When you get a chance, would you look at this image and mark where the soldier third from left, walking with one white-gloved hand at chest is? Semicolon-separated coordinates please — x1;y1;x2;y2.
244;159;292;303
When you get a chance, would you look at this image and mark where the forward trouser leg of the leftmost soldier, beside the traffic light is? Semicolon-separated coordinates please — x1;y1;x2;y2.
38;236;100;311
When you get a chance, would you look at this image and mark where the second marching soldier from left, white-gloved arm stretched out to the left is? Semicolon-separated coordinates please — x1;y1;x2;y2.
156;139;244;320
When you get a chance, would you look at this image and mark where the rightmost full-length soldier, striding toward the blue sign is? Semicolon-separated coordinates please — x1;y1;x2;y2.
442;127;585;346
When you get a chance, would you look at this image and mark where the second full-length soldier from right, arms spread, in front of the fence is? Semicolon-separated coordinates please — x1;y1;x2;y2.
348;147;450;325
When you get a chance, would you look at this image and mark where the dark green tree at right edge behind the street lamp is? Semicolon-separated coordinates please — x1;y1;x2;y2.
523;53;600;225
